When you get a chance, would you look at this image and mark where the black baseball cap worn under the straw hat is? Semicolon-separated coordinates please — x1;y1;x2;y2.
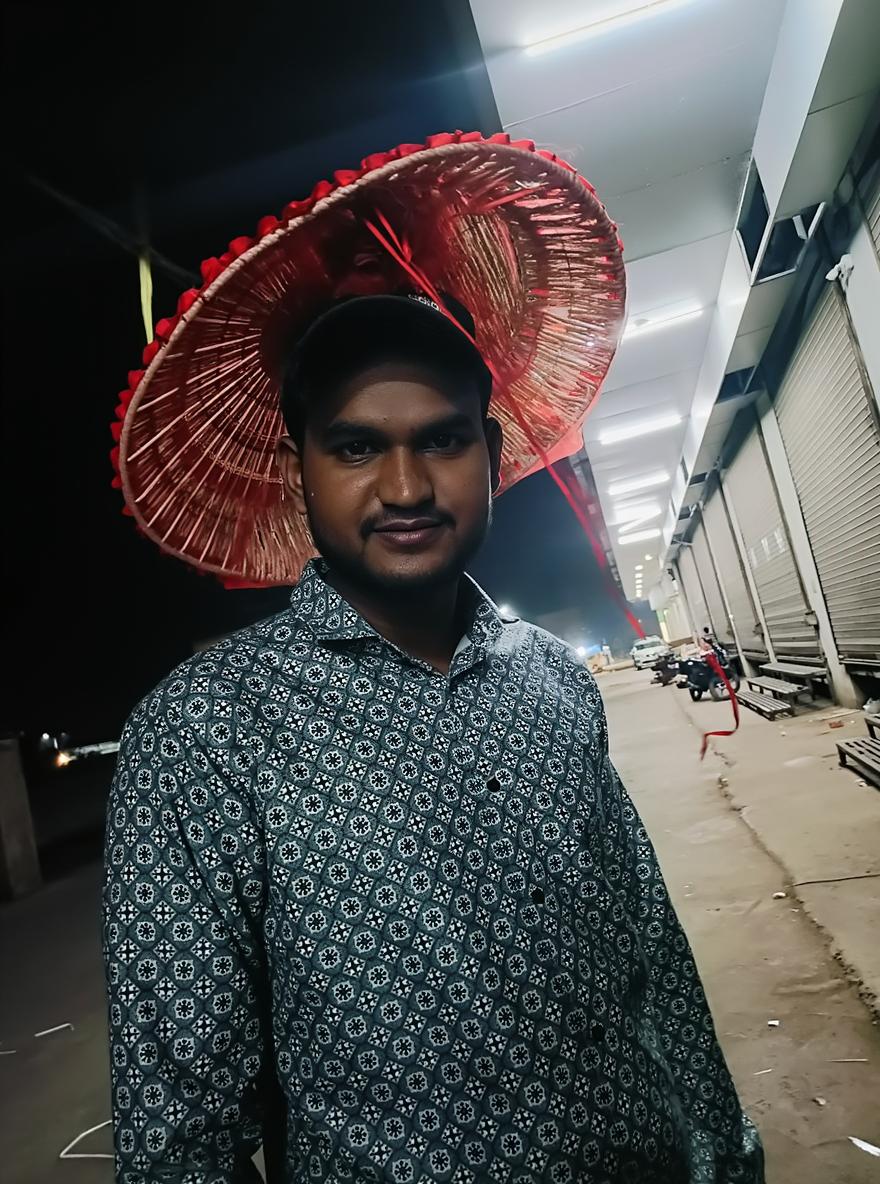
281;292;492;435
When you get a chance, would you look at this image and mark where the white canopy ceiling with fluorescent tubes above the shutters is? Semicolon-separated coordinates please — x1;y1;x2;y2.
471;0;880;593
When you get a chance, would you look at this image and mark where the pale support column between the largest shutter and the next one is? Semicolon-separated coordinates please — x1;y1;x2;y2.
757;392;862;707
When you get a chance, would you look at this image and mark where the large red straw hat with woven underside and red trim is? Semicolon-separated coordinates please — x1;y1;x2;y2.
111;133;625;585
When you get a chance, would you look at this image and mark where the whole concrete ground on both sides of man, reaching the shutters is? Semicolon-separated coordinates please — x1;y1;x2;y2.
0;671;880;1184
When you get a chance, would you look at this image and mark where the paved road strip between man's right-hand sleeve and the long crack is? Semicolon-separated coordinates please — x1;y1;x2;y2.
600;671;880;1184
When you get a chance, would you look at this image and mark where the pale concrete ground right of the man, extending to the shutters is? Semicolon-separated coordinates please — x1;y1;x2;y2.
600;671;880;1184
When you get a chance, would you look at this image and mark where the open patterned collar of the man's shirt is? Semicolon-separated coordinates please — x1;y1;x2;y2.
290;559;509;669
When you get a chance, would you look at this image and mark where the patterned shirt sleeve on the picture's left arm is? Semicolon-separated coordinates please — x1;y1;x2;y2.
103;683;270;1184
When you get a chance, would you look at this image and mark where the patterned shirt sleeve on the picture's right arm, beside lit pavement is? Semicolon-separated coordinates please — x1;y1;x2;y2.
600;734;764;1184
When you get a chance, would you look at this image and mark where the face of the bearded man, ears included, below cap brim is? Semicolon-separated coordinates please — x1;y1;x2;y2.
278;362;501;593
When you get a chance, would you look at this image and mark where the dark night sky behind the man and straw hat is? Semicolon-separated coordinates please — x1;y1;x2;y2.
0;0;649;742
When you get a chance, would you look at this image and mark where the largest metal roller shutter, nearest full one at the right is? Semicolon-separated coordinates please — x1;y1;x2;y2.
775;285;880;661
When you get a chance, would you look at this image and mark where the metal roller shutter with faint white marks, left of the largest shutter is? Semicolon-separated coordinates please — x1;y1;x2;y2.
724;425;822;662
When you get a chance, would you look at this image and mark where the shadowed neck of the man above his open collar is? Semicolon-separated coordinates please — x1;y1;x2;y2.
325;571;468;674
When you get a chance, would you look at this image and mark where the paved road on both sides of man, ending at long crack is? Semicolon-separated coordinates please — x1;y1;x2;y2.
0;673;880;1184
